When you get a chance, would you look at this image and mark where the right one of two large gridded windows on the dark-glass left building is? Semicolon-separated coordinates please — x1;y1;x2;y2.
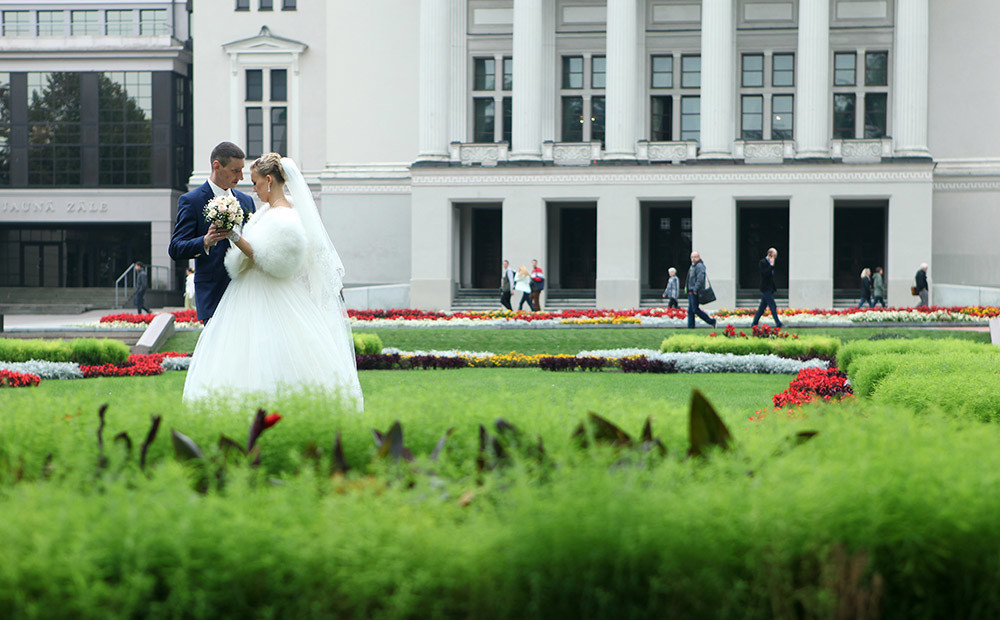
97;71;153;185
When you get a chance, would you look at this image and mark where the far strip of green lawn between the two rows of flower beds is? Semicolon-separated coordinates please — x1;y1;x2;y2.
163;327;990;354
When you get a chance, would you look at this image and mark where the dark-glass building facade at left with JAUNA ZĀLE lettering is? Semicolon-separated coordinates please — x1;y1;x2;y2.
0;0;192;288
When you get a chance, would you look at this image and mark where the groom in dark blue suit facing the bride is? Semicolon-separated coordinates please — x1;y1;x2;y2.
169;142;255;323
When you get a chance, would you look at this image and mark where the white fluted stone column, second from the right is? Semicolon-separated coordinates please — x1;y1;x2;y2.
795;0;833;158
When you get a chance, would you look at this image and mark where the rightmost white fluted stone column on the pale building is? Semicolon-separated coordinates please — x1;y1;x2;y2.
892;0;930;157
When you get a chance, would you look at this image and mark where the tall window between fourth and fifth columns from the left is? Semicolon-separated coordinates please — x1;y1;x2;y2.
739;50;795;140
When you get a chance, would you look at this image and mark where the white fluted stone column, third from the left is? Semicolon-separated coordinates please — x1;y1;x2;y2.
604;0;643;160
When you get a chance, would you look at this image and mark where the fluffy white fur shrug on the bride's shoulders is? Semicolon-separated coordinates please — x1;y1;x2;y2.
225;207;306;278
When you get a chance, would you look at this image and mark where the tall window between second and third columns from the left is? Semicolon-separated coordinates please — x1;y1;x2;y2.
560;54;607;143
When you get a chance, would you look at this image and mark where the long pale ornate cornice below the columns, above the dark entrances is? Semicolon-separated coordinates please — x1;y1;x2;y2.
412;170;933;186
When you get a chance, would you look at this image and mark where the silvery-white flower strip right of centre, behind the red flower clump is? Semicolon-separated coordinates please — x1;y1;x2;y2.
576;349;828;374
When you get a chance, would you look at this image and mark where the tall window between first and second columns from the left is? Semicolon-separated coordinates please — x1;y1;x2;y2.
472;56;514;144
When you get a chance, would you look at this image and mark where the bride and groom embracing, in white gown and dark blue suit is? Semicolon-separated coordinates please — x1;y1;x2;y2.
170;142;363;408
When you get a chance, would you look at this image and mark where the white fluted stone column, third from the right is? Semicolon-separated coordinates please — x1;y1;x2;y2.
700;0;736;159
